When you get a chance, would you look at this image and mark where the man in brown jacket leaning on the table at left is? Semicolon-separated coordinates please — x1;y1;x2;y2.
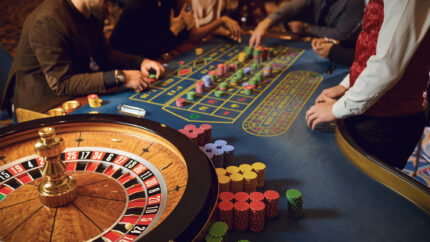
1;0;164;113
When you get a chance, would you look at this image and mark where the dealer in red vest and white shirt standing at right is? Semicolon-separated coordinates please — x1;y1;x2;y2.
306;0;430;169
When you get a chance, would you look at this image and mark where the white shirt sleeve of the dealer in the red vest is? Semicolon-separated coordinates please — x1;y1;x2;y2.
332;0;430;118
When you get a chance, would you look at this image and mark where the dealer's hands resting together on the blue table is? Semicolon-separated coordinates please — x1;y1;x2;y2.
306;96;337;130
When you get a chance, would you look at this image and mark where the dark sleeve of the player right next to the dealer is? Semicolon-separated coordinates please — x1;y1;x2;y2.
311;0;364;40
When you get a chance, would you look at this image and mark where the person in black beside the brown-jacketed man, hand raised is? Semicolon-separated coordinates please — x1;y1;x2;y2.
109;0;194;59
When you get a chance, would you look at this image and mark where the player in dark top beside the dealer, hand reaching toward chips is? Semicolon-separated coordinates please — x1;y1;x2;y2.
249;0;364;46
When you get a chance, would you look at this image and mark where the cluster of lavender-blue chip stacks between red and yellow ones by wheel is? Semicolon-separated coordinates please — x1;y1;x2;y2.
200;140;235;168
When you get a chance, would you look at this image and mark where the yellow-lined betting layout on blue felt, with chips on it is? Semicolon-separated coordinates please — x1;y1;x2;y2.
130;41;322;136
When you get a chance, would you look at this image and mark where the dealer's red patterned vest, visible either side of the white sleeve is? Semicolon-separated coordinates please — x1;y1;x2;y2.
350;0;430;117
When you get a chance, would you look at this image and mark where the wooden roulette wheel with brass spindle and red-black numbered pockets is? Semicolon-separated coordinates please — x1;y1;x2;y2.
0;114;218;241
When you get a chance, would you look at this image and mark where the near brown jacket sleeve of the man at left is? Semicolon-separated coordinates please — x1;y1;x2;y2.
29;18;106;96
